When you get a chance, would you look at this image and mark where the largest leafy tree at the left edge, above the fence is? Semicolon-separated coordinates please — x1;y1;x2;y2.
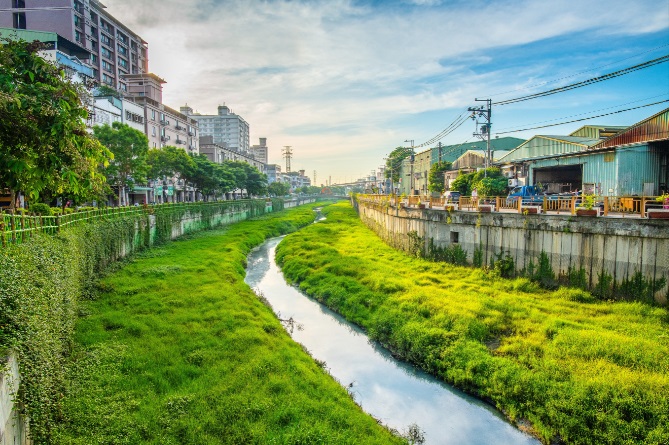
0;39;113;206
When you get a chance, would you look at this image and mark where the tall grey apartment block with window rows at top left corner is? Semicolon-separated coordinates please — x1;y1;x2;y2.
0;0;149;92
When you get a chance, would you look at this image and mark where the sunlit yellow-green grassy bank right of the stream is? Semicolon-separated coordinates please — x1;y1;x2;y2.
277;204;669;445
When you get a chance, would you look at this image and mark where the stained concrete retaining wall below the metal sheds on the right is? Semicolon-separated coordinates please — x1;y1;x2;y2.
358;202;669;303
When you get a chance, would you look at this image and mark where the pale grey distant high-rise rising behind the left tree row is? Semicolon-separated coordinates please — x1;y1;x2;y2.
181;105;250;155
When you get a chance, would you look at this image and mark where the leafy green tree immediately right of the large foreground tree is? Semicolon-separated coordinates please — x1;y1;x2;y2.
93;122;149;205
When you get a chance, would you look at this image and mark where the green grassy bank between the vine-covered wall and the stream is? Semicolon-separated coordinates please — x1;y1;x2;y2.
54;206;405;445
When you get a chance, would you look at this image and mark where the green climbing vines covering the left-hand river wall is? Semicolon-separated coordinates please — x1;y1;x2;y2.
0;200;274;444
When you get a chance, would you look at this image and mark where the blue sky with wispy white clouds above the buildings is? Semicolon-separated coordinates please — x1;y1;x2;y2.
103;0;669;185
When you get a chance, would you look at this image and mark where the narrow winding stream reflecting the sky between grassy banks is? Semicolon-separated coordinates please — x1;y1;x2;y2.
246;237;539;445
